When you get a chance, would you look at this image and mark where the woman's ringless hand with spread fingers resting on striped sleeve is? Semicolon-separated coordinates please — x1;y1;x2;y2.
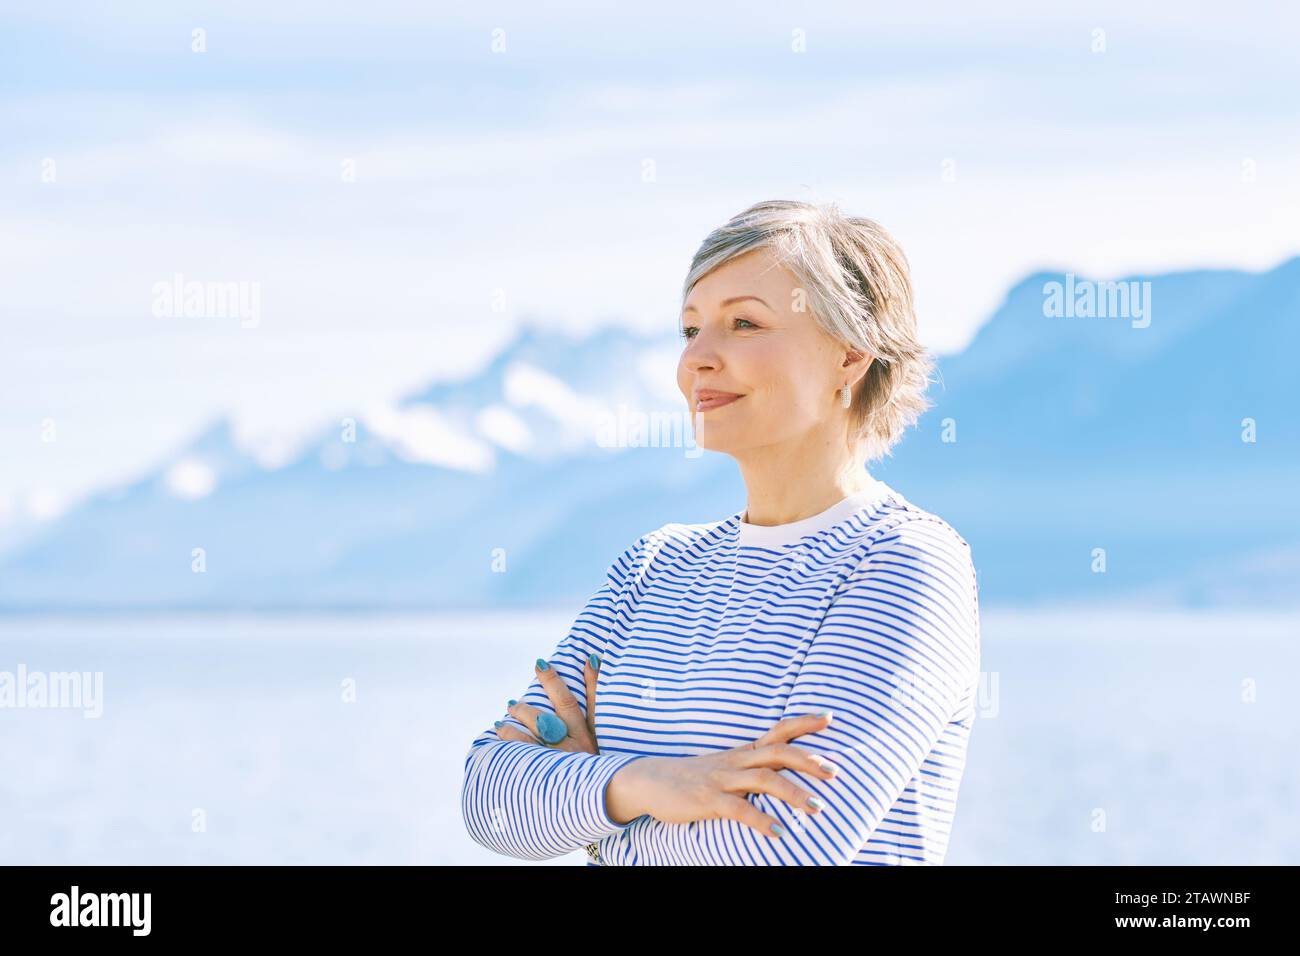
605;713;836;838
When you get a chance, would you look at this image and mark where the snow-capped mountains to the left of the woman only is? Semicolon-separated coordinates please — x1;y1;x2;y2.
0;321;744;609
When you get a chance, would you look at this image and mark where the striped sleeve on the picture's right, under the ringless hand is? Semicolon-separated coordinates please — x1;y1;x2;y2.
602;518;979;865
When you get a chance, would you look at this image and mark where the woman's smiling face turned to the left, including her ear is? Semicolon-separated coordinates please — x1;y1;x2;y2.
677;250;866;454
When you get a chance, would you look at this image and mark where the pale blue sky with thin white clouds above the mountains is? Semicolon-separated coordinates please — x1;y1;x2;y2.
0;3;1300;532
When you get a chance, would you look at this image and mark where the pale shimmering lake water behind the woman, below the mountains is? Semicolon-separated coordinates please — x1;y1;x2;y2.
0;609;1300;865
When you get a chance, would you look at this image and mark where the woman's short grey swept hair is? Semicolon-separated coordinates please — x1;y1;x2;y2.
681;199;935;460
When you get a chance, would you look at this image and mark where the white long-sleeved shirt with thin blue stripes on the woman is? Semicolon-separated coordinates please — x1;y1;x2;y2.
462;479;980;866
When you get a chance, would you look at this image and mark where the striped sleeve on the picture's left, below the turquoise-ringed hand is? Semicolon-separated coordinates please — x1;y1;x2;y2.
460;537;646;860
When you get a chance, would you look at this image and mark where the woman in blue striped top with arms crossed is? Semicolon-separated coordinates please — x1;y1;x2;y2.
462;202;980;865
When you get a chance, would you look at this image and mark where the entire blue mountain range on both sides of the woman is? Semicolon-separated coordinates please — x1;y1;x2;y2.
0;259;1300;610
